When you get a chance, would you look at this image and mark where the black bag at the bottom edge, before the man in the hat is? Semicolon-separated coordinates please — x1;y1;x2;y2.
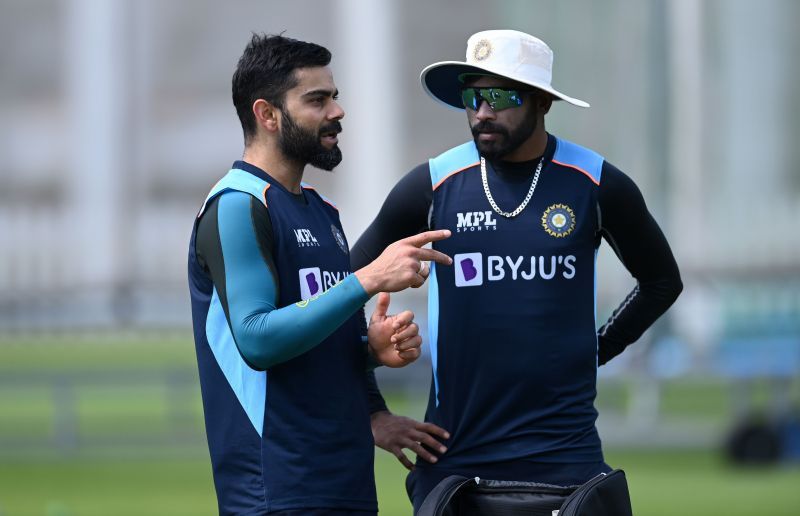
417;469;633;516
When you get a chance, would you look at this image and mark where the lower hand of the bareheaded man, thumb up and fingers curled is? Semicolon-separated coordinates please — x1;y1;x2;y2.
367;292;422;367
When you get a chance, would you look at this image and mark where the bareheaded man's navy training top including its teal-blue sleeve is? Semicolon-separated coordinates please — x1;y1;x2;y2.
189;162;377;514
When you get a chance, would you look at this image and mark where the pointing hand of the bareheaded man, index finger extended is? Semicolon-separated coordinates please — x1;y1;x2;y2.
355;229;453;297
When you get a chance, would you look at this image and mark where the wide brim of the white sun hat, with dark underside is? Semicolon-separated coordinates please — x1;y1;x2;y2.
419;61;589;109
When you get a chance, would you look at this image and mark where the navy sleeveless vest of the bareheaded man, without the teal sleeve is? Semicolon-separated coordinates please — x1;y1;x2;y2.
189;166;377;514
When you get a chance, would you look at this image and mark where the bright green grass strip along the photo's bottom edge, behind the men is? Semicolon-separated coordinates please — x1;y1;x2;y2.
0;450;800;516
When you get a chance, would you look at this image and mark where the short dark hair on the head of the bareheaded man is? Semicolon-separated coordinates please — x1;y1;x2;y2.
232;33;331;141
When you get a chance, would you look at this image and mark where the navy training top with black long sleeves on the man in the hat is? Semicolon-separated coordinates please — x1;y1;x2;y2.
352;135;681;472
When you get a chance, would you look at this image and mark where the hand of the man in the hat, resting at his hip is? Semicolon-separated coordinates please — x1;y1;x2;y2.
370;410;450;471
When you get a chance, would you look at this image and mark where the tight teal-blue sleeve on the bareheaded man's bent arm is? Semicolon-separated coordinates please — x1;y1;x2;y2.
217;192;369;369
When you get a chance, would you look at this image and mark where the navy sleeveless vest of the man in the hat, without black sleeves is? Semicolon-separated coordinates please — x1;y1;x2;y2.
426;139;603;468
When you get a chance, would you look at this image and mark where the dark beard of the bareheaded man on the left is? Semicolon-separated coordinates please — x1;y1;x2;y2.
278;110;342;170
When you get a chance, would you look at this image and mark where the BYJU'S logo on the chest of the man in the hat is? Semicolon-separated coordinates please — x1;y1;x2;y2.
453;253;576;287
